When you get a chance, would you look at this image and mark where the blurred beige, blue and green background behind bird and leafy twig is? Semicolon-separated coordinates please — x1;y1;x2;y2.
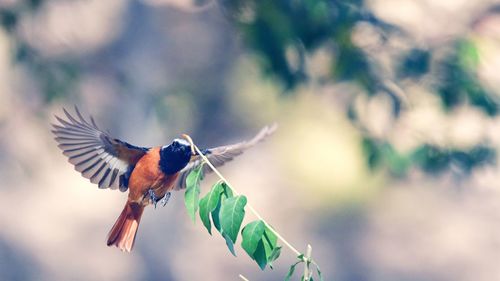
0;0;500;281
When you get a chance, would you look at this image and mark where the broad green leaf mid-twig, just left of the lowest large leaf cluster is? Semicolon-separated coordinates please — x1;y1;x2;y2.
219;195;247;243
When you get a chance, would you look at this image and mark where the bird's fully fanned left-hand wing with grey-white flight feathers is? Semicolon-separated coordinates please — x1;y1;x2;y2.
52;106;149;191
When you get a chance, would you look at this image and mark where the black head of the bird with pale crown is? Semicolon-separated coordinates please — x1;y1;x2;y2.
160;139;193;174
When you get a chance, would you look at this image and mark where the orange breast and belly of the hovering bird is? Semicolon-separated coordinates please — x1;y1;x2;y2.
128;147;178;205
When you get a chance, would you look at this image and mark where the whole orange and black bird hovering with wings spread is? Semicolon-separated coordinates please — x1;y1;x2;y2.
51;106;277;252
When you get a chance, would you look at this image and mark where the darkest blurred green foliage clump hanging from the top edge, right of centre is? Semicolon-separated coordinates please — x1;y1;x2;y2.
224;0;378;92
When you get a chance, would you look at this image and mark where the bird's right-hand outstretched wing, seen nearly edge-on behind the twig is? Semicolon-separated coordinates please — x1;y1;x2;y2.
175;124;278;190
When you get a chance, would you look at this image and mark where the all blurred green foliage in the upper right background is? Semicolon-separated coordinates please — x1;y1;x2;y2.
225;0;498;176
